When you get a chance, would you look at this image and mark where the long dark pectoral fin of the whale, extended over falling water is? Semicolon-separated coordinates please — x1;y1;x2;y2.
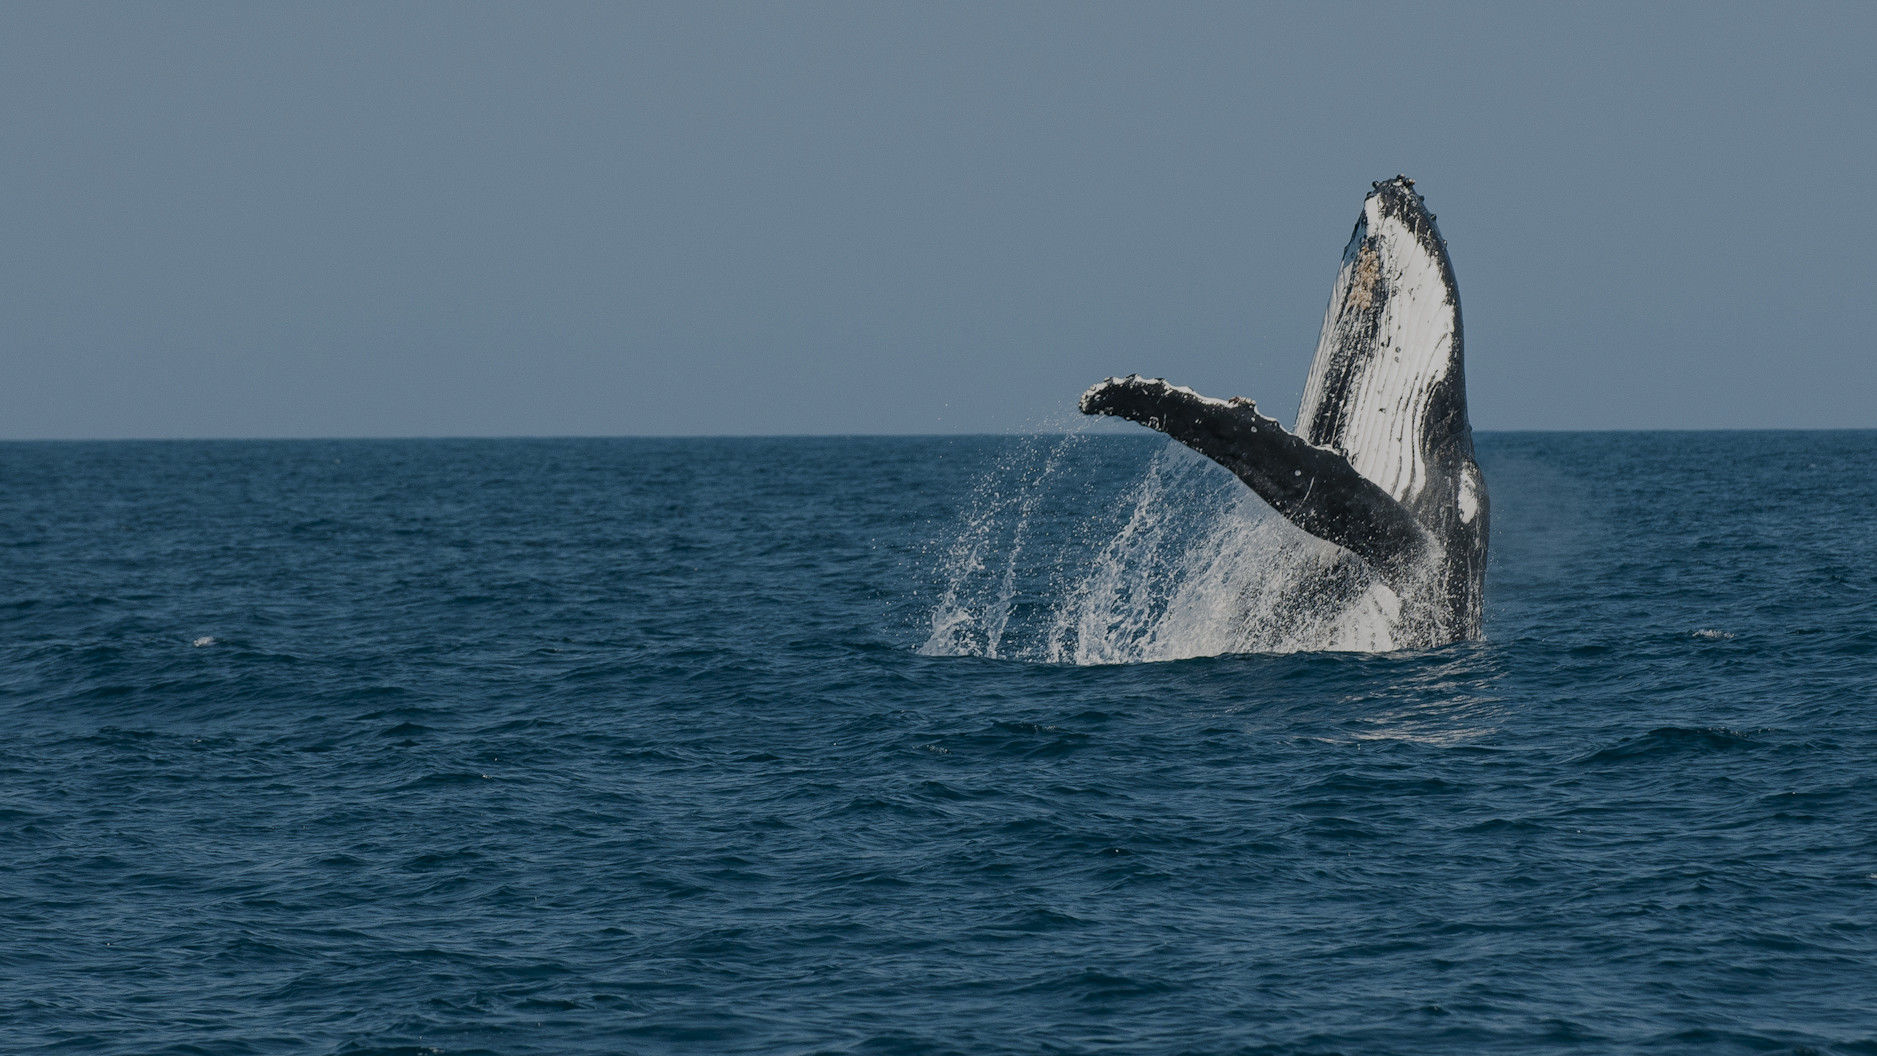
1081;375;1434;581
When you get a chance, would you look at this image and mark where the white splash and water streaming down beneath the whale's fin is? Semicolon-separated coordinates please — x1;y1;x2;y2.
920;435;1410;664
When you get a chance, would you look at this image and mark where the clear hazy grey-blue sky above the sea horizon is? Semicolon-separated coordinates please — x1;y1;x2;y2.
0;0;1877;439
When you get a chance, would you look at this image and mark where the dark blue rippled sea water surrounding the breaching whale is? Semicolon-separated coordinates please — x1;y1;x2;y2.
0;433;1877;1054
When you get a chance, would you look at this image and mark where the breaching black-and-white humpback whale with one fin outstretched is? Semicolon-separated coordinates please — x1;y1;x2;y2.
1081;176;1487;647
